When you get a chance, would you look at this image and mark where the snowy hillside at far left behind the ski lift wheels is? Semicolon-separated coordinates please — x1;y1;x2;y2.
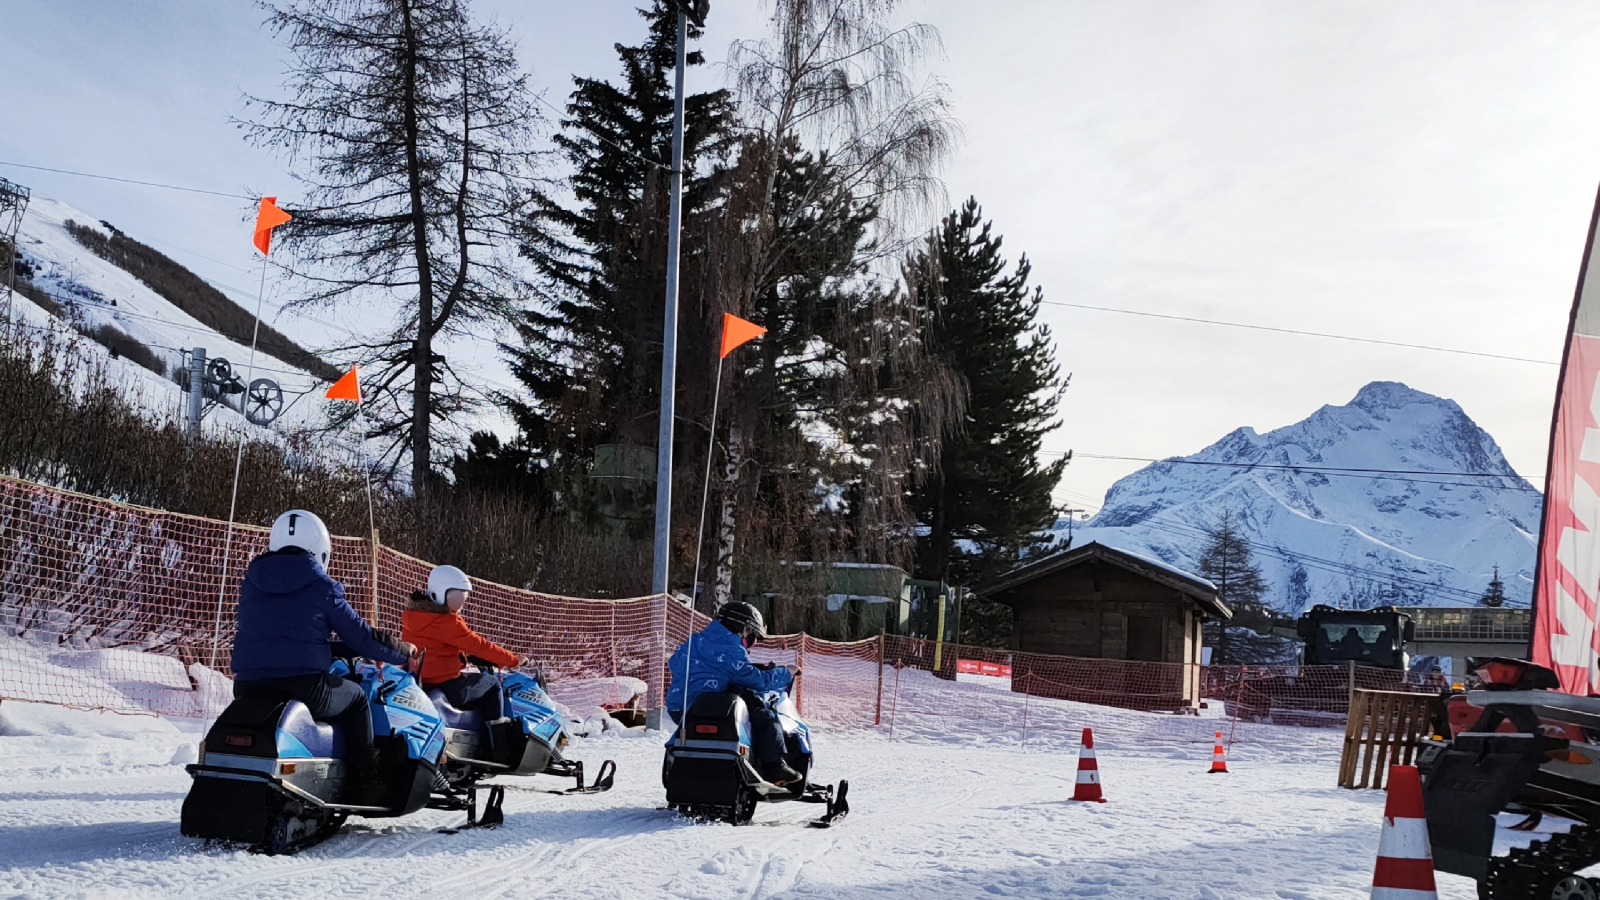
14;197;328;428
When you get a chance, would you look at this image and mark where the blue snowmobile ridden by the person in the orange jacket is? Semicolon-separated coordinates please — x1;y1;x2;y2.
427;658;616;828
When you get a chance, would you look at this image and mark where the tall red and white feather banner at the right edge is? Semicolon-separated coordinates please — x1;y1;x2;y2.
1533;184;1600;695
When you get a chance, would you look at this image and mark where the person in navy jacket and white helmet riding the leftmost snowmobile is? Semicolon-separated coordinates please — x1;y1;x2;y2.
232;509;416;806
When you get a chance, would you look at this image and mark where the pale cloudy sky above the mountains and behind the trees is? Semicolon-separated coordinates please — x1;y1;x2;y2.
0;0;1600;509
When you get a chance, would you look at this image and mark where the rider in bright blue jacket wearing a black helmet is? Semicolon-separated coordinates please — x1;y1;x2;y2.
667;601;803;786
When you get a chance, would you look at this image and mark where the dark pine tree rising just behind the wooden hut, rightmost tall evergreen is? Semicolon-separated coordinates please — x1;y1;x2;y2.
906;199;1066;583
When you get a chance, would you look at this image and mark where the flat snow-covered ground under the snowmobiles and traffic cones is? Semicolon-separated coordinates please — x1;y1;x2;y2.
0;685;1523;900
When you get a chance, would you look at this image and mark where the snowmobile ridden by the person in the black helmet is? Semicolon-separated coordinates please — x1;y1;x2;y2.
661;679;850;828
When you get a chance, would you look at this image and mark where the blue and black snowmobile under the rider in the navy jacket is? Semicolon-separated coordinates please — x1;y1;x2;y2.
181;650;445;854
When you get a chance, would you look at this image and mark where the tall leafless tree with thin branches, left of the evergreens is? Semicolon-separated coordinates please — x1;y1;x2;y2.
242;0;539;493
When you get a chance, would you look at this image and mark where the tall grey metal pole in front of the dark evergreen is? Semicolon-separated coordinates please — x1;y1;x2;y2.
650;5;693;595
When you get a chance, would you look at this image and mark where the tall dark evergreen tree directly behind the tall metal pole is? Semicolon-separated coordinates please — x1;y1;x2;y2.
504;0;731;471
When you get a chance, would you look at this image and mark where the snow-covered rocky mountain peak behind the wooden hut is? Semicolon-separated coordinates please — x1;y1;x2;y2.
1056;381;1542;613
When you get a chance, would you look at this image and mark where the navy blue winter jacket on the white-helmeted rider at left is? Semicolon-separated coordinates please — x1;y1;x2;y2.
234;548;406;681
